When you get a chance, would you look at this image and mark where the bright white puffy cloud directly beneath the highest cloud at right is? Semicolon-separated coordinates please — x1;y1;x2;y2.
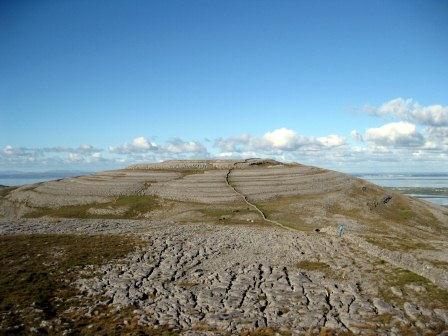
365;121;424;147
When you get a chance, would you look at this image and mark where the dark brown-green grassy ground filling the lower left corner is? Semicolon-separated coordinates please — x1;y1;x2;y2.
0;235;150;335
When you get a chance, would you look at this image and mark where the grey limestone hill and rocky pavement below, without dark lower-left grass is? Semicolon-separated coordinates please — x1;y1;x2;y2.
0;158;448;334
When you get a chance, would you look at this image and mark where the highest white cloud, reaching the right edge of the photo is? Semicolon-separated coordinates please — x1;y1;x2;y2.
364;98;448;127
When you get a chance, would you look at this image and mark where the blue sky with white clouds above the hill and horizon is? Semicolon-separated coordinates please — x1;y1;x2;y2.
0;1;448;171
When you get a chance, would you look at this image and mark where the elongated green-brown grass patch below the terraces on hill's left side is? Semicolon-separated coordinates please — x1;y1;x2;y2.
26;196;159;219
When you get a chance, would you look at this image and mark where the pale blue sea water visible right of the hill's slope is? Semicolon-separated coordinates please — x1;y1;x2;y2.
352;173;448;206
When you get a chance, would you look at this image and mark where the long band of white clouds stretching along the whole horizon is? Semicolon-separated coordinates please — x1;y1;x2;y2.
0;98;448;169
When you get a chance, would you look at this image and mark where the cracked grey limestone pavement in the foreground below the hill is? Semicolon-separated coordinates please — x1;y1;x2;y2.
70;220;446;334
